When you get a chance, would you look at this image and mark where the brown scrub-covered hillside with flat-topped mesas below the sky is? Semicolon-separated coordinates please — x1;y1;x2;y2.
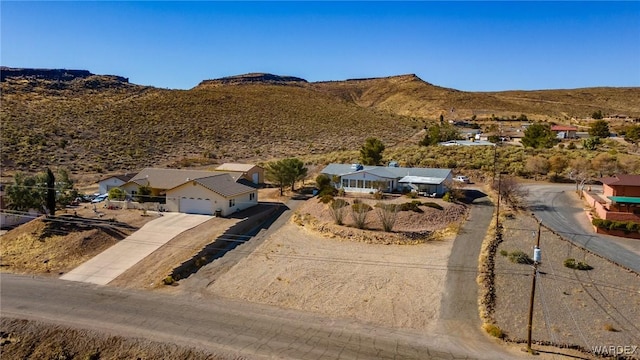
0;69;640;174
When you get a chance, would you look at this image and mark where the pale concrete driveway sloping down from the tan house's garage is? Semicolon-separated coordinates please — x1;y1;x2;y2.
60;213;212;285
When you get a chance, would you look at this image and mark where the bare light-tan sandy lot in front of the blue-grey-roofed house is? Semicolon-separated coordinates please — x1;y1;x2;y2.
185;198;465;329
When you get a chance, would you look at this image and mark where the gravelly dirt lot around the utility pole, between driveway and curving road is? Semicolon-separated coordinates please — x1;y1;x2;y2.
495;198;640;358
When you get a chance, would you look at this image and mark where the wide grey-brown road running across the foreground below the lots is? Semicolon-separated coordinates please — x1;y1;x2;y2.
0;274;527;360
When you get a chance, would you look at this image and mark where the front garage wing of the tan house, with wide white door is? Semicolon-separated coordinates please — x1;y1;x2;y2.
165;173;258;216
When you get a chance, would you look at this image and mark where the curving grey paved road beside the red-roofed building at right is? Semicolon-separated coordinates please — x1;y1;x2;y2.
528;184;640;273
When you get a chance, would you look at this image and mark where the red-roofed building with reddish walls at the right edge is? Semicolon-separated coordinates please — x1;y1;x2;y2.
585;174;640;222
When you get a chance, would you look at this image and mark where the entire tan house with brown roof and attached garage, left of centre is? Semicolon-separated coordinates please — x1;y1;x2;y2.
120;168;258;216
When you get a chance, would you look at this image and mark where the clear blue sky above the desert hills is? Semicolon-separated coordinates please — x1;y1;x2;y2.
0;1;640;91
